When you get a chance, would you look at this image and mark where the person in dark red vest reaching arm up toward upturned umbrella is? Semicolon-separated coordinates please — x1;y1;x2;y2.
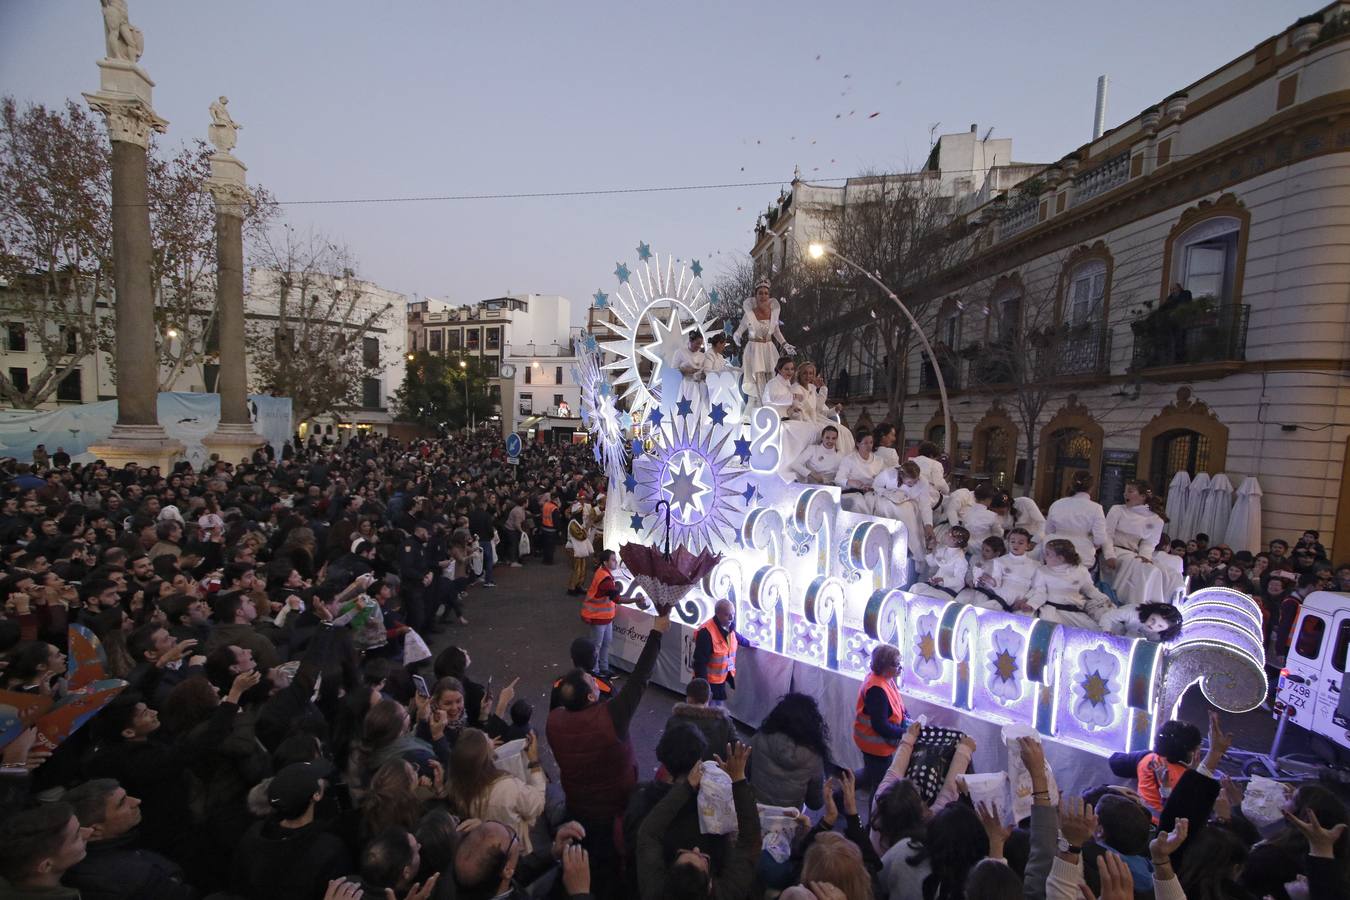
545;606;671;900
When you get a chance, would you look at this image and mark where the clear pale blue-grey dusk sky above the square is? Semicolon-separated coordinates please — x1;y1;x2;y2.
0;0;1306;318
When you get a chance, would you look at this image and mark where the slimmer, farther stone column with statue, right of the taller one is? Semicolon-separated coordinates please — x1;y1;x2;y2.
201;97;263;463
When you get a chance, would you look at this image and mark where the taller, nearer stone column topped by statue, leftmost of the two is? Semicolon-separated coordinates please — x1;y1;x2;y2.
85;3;184;472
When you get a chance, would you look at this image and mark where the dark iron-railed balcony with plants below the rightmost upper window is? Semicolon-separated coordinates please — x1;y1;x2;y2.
1130;301;1251;371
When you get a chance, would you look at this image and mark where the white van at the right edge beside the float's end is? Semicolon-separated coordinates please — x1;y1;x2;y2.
1274;591;1350;748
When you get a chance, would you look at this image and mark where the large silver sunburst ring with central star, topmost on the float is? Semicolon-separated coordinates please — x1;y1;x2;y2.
595;243;711;421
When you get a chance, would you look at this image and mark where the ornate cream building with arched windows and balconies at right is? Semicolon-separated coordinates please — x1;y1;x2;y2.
777;3;1350;556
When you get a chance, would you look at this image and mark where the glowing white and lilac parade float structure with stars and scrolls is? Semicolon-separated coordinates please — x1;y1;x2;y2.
582;244;1266;754
